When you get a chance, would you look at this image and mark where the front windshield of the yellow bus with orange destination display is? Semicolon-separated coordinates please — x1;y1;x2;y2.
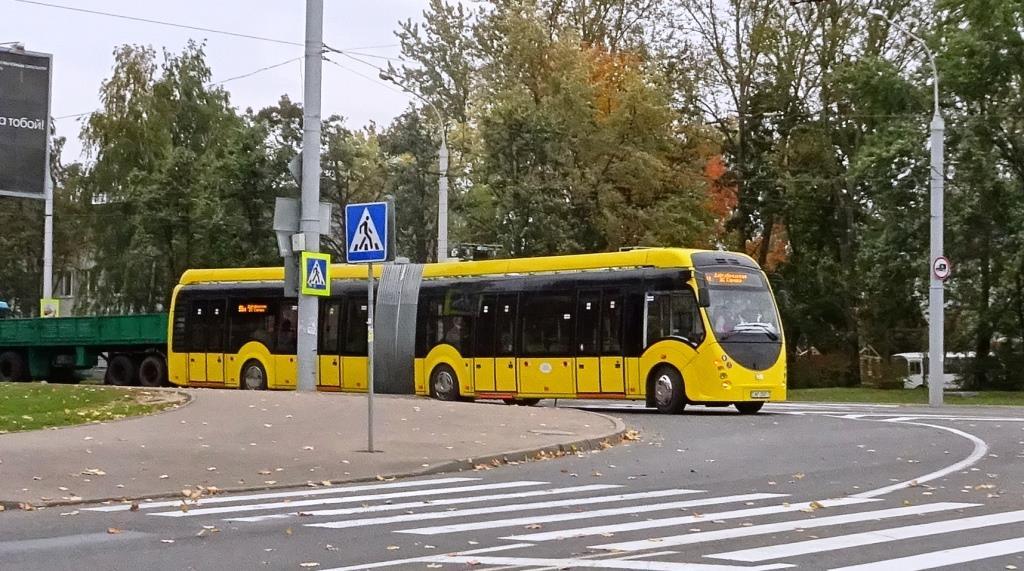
706;270;782;341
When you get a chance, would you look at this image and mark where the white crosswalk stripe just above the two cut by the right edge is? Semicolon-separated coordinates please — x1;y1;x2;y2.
591;505;981;552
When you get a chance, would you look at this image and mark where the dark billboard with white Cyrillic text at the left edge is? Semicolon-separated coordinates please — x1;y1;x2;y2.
0;48;52;199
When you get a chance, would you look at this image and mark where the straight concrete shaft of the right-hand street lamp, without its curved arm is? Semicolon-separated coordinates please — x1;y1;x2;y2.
928;112;946;406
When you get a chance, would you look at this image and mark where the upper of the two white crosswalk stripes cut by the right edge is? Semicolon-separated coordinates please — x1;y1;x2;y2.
705;510;1024;563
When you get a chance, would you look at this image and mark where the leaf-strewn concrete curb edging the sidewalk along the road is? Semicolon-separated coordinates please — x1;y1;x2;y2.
0;411;627;511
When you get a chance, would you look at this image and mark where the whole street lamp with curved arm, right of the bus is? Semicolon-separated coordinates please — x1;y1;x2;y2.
867;8;949;406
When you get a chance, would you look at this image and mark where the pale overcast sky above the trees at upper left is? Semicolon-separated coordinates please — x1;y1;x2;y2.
0;0;427;160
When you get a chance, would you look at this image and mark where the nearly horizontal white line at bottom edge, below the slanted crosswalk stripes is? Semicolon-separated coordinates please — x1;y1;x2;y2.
356;555;793;571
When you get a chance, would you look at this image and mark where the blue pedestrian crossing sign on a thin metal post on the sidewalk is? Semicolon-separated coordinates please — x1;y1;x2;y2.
345;203;393;452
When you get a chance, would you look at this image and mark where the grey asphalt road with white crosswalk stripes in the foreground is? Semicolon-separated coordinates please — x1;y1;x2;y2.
0;403;1024;571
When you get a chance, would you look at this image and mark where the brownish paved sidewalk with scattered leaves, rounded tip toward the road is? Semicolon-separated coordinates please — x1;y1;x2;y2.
0;389;624;509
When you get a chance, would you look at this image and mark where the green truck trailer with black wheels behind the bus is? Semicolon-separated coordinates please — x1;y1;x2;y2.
0;313;167;387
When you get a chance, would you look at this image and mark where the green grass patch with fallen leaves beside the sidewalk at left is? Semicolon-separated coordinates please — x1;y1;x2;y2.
0;383;181;434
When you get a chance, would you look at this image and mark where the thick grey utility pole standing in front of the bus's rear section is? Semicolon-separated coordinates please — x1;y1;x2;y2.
296;0;330;392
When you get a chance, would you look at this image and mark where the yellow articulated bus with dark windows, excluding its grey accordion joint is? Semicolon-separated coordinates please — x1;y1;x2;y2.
168;249;786;413
